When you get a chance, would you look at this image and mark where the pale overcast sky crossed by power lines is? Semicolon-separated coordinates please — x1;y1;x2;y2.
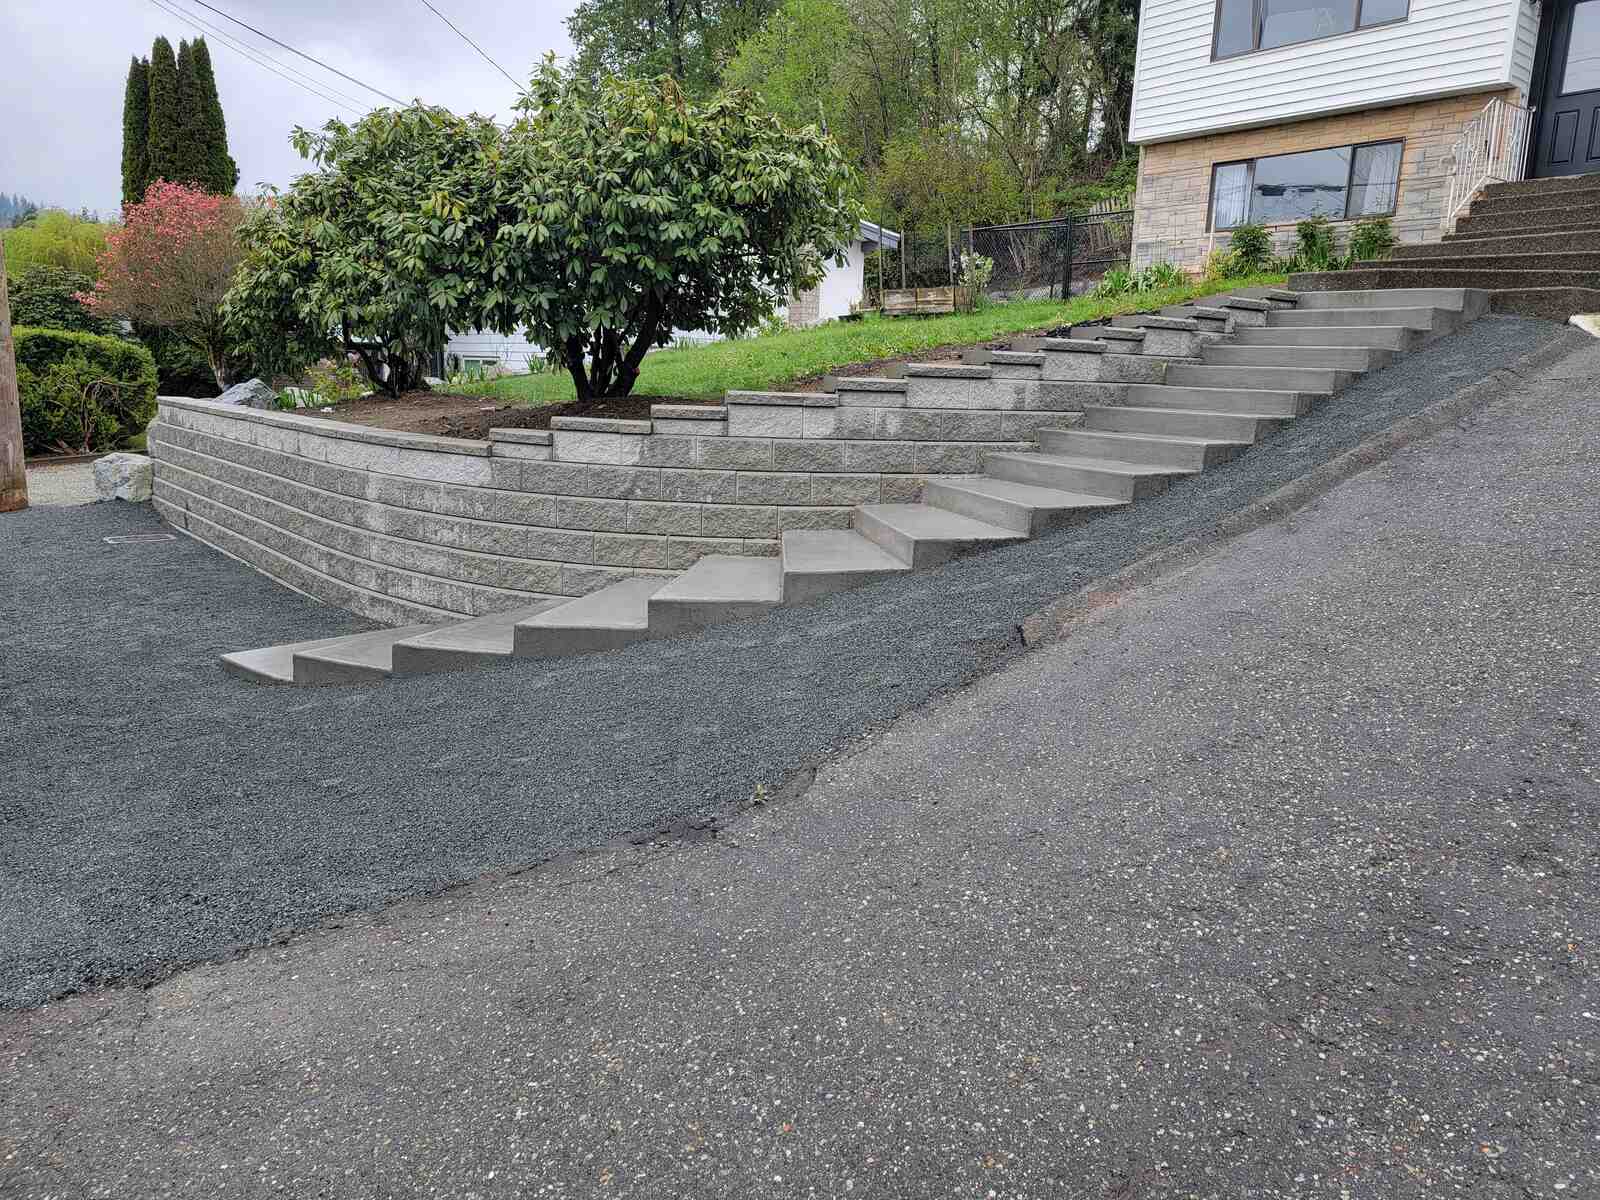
0;0;574;214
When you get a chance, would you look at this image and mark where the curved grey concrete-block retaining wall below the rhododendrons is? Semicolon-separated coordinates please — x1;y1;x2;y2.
149;376;1104;624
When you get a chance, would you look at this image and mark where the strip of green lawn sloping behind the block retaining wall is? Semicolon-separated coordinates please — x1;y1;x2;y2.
470;275;1285;405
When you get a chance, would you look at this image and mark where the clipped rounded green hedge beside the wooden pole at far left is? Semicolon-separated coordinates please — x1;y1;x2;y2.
16;328;155;454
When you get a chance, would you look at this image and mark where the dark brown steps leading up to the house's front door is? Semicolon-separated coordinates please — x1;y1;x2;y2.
1290;174;1600;320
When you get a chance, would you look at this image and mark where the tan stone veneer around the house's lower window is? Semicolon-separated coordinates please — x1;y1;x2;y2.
1133;88;1523;270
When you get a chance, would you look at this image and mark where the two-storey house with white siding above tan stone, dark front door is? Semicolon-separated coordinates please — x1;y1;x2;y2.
1131;0;1600;267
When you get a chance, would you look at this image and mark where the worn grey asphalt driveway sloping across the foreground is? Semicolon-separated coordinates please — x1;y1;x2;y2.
0;334;1600;1200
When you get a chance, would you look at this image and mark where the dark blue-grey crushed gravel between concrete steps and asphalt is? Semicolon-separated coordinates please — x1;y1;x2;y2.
0;317;1581;1006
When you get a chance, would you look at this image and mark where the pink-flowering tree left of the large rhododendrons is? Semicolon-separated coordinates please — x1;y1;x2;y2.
78;179;245;387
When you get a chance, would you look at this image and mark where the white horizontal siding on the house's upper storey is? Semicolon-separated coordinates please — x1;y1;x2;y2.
1133;0;1538;142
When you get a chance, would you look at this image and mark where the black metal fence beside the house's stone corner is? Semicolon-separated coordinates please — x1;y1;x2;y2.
962;211;1133;299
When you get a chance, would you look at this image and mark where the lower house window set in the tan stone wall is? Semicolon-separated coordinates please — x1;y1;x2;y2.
1211;142;1405;229
